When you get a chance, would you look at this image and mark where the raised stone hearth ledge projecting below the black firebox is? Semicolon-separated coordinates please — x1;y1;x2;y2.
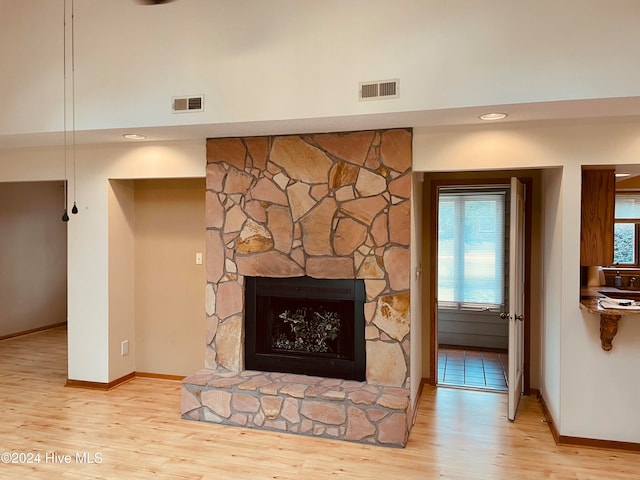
181;369;410;447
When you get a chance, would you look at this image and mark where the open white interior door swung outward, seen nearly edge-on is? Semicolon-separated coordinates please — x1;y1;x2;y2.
508;177;526;420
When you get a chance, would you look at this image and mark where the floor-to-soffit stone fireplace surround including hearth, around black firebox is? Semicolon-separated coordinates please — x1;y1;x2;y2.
182;129;412;445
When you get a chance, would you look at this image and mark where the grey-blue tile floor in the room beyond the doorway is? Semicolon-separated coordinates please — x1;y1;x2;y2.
438;347;509;392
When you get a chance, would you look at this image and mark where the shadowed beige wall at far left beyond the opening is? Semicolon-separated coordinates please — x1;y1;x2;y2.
0;180;68;339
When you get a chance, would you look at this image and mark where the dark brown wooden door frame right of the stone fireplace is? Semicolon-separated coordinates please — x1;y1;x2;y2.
429;171;533;395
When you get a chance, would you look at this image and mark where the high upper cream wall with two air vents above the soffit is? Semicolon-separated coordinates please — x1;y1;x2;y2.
0;0;640;139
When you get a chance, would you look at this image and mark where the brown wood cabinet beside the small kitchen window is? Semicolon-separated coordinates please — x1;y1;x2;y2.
580;169;616;266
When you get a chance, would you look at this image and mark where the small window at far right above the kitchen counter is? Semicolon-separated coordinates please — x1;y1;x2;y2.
613;192;640;265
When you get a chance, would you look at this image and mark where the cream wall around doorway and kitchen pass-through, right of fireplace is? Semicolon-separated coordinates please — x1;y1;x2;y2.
414;120;640;442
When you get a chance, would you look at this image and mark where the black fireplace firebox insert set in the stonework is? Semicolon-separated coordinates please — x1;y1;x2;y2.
245;277;366;381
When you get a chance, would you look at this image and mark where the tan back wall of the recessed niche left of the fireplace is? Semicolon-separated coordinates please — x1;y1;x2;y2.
134;178;207;376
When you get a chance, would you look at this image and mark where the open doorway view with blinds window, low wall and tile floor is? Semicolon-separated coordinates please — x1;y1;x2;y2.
437;185;509;392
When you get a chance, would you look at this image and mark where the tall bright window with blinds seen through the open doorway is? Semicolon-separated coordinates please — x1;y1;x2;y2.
438;188;507;309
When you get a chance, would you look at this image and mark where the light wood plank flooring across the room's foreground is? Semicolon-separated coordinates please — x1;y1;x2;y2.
0;328;640;480
